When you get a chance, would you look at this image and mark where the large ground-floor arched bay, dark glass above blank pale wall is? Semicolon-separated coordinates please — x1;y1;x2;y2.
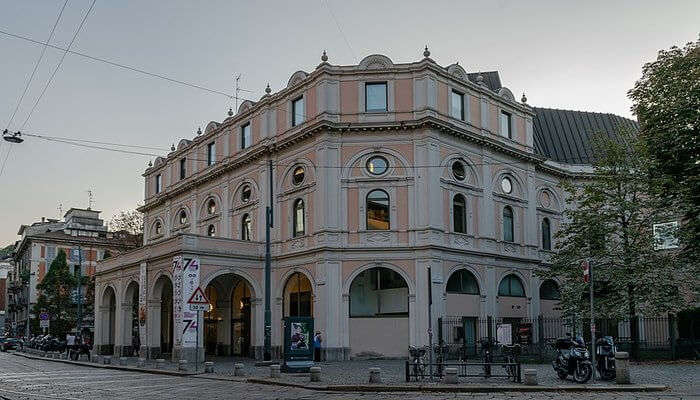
348;267;409;357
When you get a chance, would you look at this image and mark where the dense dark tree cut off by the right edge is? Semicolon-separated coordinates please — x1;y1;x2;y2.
629;40;700;262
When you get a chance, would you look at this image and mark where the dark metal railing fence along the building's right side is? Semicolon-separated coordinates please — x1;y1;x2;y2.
438;316;700;361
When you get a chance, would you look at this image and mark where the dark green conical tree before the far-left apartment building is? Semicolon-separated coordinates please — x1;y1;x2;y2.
34;250;78;338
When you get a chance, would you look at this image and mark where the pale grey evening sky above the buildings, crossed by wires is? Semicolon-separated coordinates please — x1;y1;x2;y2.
0;0;700;246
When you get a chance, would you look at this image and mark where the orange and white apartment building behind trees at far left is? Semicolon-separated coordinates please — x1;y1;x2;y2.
11;208;140;335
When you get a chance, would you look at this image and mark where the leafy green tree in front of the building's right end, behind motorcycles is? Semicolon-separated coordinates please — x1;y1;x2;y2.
539;131;695;353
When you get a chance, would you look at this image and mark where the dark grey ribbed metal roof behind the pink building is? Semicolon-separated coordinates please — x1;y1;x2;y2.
533;107;639;164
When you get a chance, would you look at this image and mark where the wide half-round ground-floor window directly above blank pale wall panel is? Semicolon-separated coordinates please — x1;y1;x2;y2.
350;267;408;317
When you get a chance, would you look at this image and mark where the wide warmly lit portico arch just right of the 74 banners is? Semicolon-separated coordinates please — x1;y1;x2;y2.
204;274;255;357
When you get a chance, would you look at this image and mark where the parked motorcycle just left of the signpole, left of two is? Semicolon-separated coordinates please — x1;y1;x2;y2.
552;336;593;383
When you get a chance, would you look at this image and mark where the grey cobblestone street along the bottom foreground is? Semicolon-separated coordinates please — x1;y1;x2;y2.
0;353;700;400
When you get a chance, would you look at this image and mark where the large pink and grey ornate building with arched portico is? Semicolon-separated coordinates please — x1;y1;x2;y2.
95;49;636;360
